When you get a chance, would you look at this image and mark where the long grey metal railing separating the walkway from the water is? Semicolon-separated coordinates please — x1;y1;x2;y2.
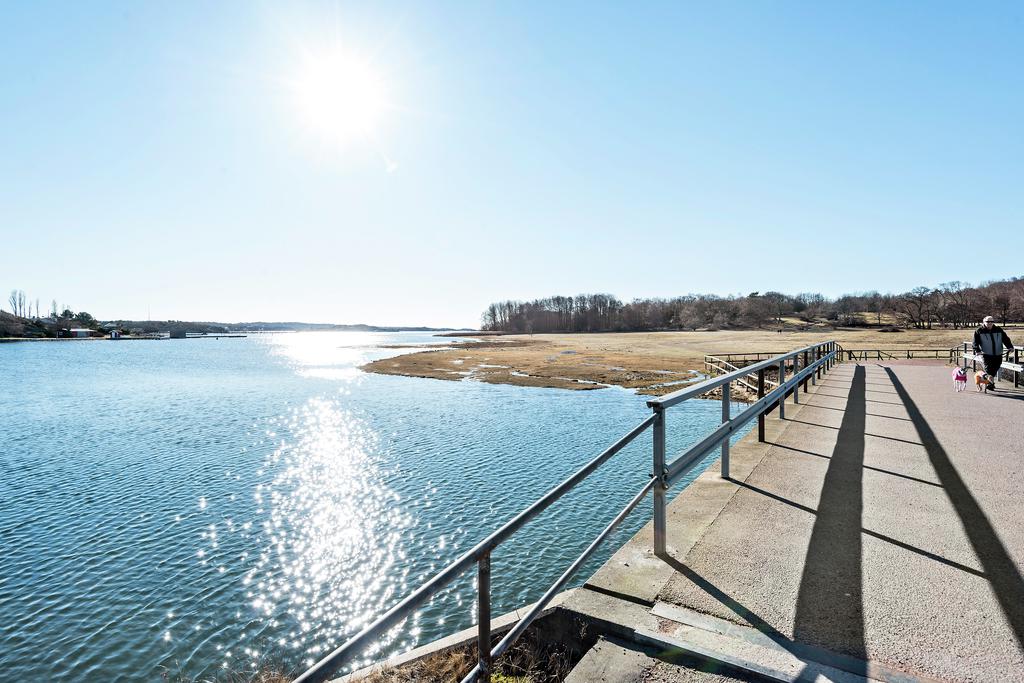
295;341;839;683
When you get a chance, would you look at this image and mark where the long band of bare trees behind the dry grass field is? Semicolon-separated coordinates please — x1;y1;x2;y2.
481;276;1024;334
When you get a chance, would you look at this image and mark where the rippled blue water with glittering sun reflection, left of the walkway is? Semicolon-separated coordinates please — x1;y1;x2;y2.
0;333;741;681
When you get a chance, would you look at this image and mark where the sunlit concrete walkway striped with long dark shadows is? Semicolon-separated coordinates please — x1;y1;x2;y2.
565;361;1024;681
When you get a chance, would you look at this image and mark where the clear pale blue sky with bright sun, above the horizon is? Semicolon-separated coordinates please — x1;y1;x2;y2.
0;0;1024;326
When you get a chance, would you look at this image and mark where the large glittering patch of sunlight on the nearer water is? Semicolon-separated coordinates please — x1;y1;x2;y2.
243;398;414;664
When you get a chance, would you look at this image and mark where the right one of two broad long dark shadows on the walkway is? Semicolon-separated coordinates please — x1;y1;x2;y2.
883;368;1024;651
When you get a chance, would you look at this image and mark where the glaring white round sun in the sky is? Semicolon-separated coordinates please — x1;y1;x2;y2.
293;50;388;146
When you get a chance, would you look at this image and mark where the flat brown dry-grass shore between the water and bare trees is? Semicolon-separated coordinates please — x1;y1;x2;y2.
362;328;991;395
